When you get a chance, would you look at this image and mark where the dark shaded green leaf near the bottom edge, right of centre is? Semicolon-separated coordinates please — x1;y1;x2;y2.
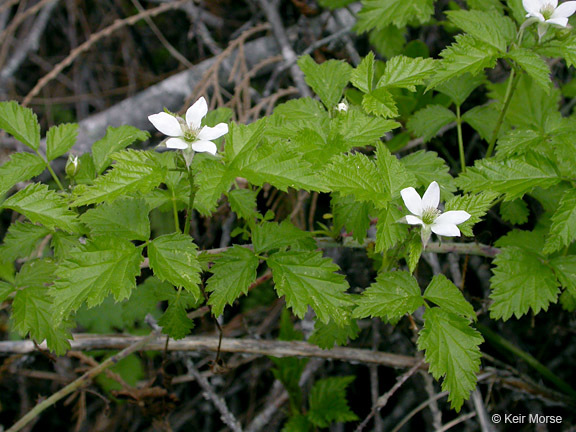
307;376;358;428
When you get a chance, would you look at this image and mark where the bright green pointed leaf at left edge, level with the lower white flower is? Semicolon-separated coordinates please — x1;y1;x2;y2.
2;183;80;233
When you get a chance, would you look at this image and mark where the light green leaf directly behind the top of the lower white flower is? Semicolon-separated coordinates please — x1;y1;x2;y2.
400;150;455;194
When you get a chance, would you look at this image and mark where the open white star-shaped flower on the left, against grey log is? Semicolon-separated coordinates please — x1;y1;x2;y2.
148;97;228;155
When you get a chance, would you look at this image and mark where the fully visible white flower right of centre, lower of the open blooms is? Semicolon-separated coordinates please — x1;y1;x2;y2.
400;181;470;245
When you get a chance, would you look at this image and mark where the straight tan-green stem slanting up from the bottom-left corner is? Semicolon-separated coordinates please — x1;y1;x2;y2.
6;331;158;432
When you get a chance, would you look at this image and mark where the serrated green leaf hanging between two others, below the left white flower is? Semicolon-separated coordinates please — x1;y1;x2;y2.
206;245;259;316
